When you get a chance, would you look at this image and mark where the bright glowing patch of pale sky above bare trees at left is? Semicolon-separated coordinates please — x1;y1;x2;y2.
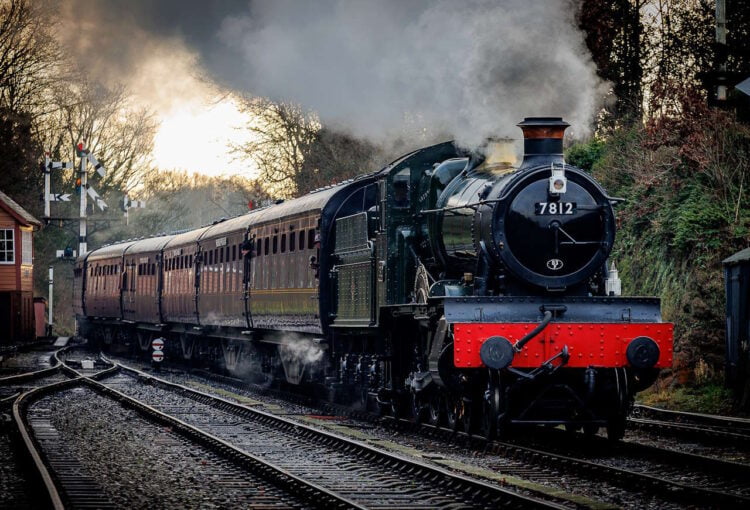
153;98;255;177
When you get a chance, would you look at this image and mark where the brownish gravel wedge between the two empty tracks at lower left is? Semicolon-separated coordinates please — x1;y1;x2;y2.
33;388;306;508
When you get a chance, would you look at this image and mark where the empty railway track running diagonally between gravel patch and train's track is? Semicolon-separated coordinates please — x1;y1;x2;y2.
92;369;562;508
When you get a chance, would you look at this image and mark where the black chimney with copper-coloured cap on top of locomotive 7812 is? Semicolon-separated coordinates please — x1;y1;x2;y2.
516;117;570;167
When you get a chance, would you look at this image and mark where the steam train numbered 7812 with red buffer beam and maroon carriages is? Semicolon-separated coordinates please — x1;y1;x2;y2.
74;117;673;439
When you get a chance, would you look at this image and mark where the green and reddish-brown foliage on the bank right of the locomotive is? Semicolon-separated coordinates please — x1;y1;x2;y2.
588;88;750;390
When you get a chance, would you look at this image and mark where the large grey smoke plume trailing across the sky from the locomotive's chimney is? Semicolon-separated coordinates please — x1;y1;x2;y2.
53;0;606;150
